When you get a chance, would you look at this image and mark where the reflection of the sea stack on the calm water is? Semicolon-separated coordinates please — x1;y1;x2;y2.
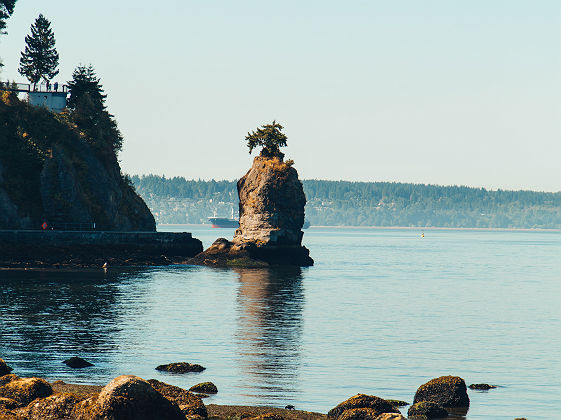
231;267;304;402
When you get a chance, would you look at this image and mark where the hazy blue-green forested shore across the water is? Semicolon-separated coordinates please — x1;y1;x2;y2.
131;175;561;229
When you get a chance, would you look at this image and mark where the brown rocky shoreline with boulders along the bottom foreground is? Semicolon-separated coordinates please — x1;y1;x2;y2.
0;358;522;420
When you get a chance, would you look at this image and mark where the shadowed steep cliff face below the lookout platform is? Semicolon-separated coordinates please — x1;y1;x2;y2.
0;92;156;231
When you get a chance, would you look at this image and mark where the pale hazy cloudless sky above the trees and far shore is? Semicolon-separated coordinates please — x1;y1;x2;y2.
0;0;561;191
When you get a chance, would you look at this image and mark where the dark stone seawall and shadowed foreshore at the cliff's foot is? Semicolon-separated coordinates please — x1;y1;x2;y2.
0;230;203;268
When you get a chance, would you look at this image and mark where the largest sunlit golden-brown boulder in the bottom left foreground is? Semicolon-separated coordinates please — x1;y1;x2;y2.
71;375;185;420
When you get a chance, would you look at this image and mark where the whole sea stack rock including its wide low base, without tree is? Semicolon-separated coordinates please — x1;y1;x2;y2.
189;156;314;267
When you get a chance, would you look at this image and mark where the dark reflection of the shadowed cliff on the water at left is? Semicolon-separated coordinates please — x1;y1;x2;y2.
0;270;131;377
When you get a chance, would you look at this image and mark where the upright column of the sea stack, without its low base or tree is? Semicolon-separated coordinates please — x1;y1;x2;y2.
234;156;306;246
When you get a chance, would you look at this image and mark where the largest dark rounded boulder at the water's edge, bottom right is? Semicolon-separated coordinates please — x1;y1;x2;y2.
413;376;469;408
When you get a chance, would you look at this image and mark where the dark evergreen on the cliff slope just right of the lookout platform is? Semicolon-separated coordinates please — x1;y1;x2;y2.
68;64;123;153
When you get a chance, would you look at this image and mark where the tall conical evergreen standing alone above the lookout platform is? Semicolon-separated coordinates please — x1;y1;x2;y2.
19;15;58;87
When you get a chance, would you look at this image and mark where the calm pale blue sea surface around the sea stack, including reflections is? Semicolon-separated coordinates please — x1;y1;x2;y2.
0;226;561;420
